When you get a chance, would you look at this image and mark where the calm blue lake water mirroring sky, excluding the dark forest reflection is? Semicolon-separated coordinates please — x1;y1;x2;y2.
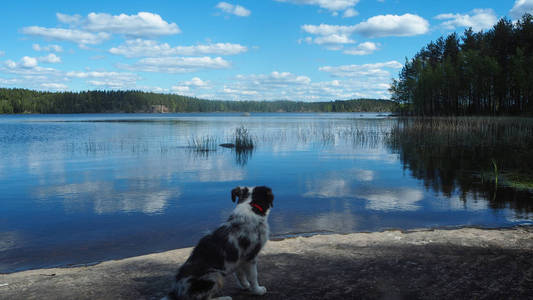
0;113;533;273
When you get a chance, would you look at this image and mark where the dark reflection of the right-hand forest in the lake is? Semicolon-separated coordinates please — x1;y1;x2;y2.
387;118;533;213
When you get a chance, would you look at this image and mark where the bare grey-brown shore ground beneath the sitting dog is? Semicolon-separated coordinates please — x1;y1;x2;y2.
0;227;533;300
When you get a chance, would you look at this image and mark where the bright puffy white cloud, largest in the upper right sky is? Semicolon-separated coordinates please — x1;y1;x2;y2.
354;14;429;37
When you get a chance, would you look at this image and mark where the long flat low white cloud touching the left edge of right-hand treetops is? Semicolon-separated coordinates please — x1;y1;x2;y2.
319;60;403;79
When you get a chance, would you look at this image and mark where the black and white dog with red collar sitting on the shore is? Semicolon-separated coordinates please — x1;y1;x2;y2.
163;186;274;300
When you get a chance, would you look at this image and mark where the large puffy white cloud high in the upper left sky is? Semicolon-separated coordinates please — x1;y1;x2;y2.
83;12;181;37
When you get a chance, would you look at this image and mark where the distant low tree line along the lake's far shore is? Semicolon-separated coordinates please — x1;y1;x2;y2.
0;88;398;114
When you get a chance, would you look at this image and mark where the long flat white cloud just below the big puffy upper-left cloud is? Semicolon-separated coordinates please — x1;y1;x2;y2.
109;39;248;57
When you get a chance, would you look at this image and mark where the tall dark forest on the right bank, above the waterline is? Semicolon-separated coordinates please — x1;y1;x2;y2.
389;14;533;116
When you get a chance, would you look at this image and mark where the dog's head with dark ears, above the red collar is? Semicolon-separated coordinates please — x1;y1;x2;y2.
231;186;274;215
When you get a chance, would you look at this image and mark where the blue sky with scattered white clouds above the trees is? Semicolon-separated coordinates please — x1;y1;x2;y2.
0;0;533;102
